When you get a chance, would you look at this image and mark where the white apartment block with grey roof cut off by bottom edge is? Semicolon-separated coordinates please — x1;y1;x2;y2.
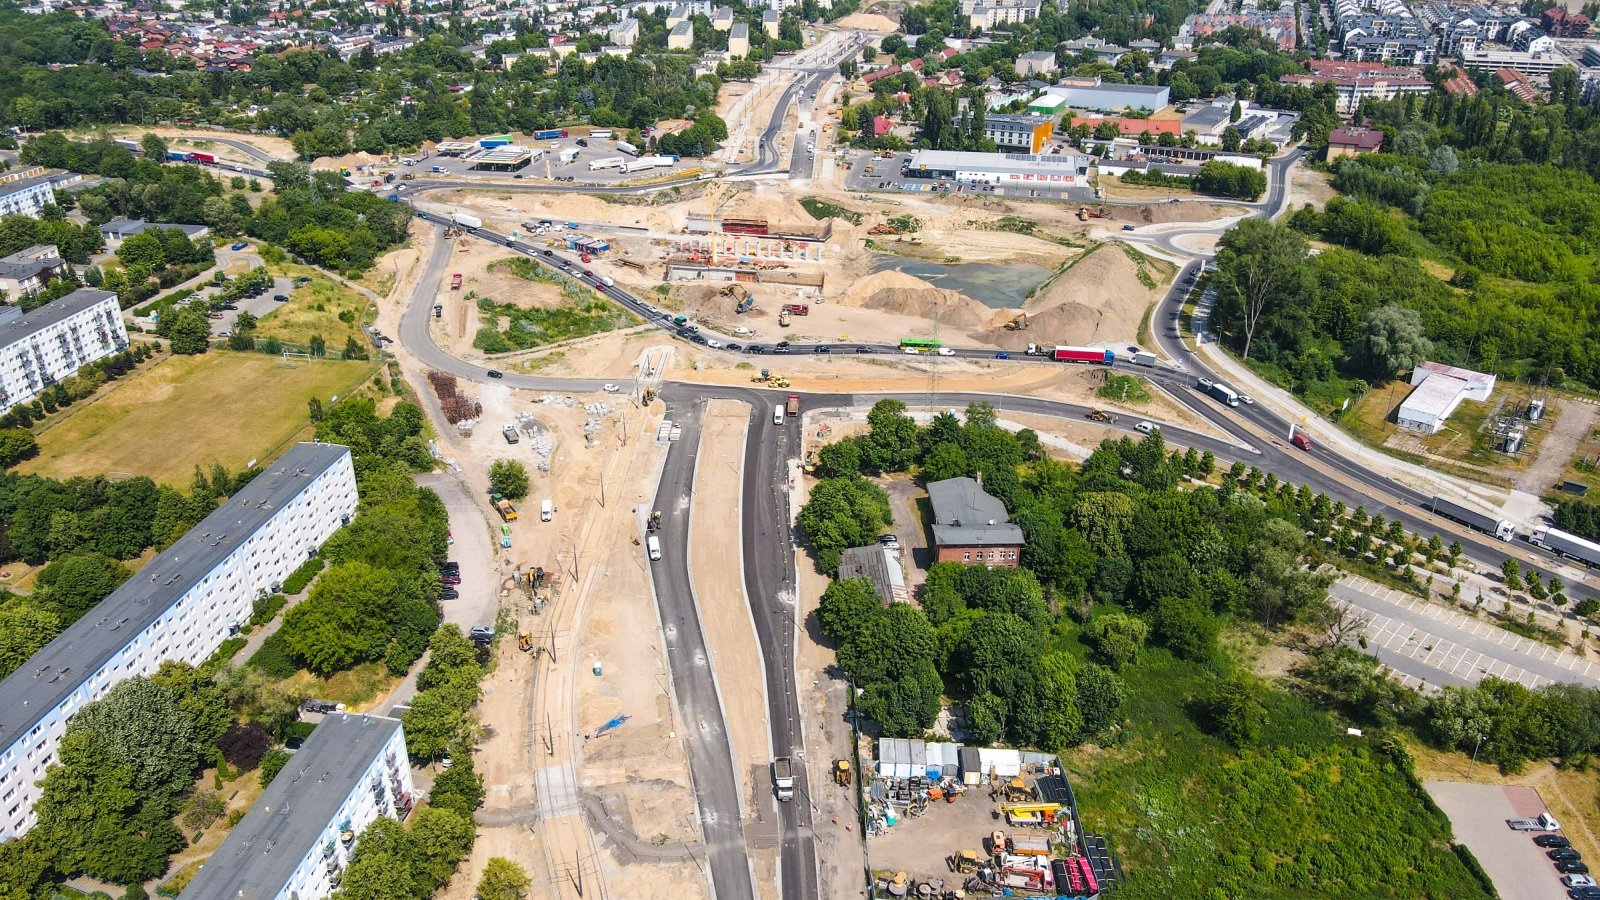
179;713;416;900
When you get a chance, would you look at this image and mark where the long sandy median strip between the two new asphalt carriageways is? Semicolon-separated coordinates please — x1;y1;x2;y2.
690;400;773;814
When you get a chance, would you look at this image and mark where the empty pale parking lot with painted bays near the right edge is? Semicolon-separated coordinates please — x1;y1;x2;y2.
1328;578;1600;687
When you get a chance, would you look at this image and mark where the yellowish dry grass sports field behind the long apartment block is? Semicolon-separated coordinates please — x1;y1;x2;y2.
19;350;374;487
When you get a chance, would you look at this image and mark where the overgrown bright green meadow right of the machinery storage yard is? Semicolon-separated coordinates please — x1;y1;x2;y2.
1062;649;1486;900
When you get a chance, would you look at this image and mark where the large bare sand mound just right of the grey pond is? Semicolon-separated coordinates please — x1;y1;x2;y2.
990;243;1158;349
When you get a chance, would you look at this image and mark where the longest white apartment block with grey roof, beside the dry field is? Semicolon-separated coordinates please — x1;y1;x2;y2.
0;441;355;841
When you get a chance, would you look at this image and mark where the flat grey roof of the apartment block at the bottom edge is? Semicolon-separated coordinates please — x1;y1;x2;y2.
172;714;400;900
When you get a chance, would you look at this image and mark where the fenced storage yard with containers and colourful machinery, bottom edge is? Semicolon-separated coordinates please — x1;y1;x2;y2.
859;738;1122;900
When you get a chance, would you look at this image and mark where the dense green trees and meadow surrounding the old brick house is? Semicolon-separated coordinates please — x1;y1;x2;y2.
800;400;1600;898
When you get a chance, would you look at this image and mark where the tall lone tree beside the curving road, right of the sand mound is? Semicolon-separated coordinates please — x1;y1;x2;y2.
1216;219;1310;359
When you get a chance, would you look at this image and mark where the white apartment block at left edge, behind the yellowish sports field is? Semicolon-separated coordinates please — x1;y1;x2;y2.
0;288;128;413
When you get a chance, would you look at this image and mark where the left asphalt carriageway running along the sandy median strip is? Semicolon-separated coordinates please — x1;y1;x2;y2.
650;397;755;900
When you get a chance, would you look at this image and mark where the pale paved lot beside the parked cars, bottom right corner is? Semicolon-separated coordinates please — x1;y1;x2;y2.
1424;781;1566;900
